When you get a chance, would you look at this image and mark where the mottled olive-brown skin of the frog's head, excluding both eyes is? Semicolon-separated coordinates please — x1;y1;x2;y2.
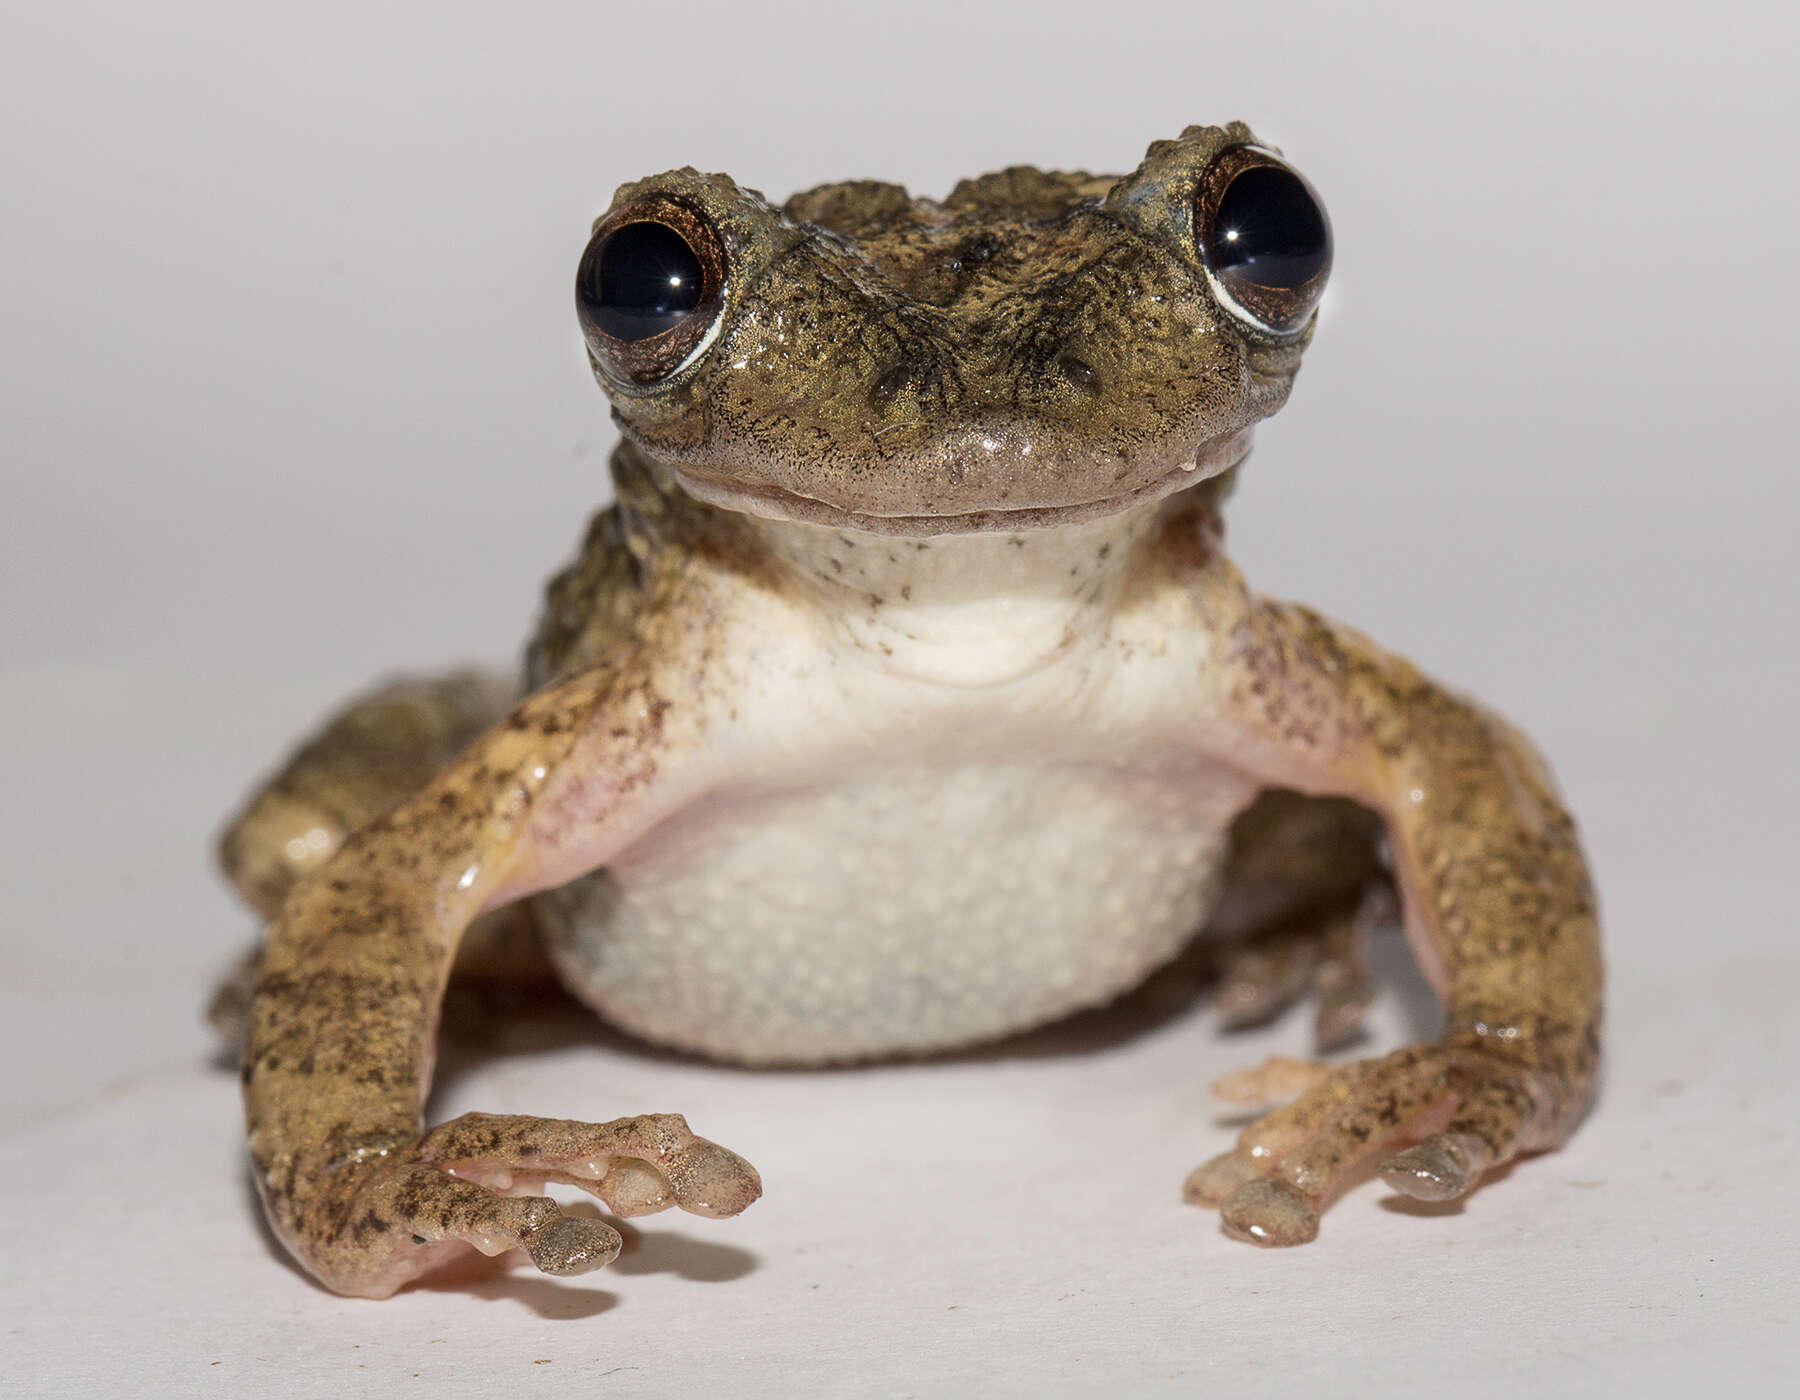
594;126;1305;534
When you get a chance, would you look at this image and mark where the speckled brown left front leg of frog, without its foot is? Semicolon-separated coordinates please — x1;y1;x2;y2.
245;669;653;1260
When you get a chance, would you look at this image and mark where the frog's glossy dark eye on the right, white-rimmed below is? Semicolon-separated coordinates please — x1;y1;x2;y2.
1193;146;1332;338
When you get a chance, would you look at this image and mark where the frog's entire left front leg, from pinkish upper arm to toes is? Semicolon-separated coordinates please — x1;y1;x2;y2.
245;646;761;1297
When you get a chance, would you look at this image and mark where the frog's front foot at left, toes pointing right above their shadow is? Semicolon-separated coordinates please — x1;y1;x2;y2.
316;1114;763;1297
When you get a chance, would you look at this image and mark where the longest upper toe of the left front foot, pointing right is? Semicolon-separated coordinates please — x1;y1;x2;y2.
418;1114;763;1216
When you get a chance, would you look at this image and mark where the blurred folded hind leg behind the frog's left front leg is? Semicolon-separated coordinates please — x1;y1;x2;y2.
207;669;547;1046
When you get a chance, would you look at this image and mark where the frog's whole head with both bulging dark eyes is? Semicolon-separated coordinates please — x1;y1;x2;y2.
576;122;1330;534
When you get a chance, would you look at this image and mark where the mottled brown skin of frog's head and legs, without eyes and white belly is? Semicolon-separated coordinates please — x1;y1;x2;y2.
225;126;1600;1296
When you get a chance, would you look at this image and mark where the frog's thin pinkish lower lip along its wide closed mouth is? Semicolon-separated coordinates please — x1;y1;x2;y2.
664;428;1251;536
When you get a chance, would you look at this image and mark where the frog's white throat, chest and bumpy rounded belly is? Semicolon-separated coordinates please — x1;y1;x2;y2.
540;504;1256;1063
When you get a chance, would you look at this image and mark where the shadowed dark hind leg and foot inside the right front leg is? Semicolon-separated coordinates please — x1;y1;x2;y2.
1208;788;1397;1051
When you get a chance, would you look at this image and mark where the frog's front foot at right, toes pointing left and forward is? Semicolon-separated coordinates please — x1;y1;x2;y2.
1184;1037;1566;1245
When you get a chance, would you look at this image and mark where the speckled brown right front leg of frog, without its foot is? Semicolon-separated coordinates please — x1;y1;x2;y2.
1233;603;1602;1132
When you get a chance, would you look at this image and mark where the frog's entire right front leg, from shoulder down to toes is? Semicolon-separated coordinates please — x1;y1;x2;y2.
1188;603;1602;1245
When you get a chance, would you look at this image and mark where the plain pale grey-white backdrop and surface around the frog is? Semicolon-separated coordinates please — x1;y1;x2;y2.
0;0;1800;1396
